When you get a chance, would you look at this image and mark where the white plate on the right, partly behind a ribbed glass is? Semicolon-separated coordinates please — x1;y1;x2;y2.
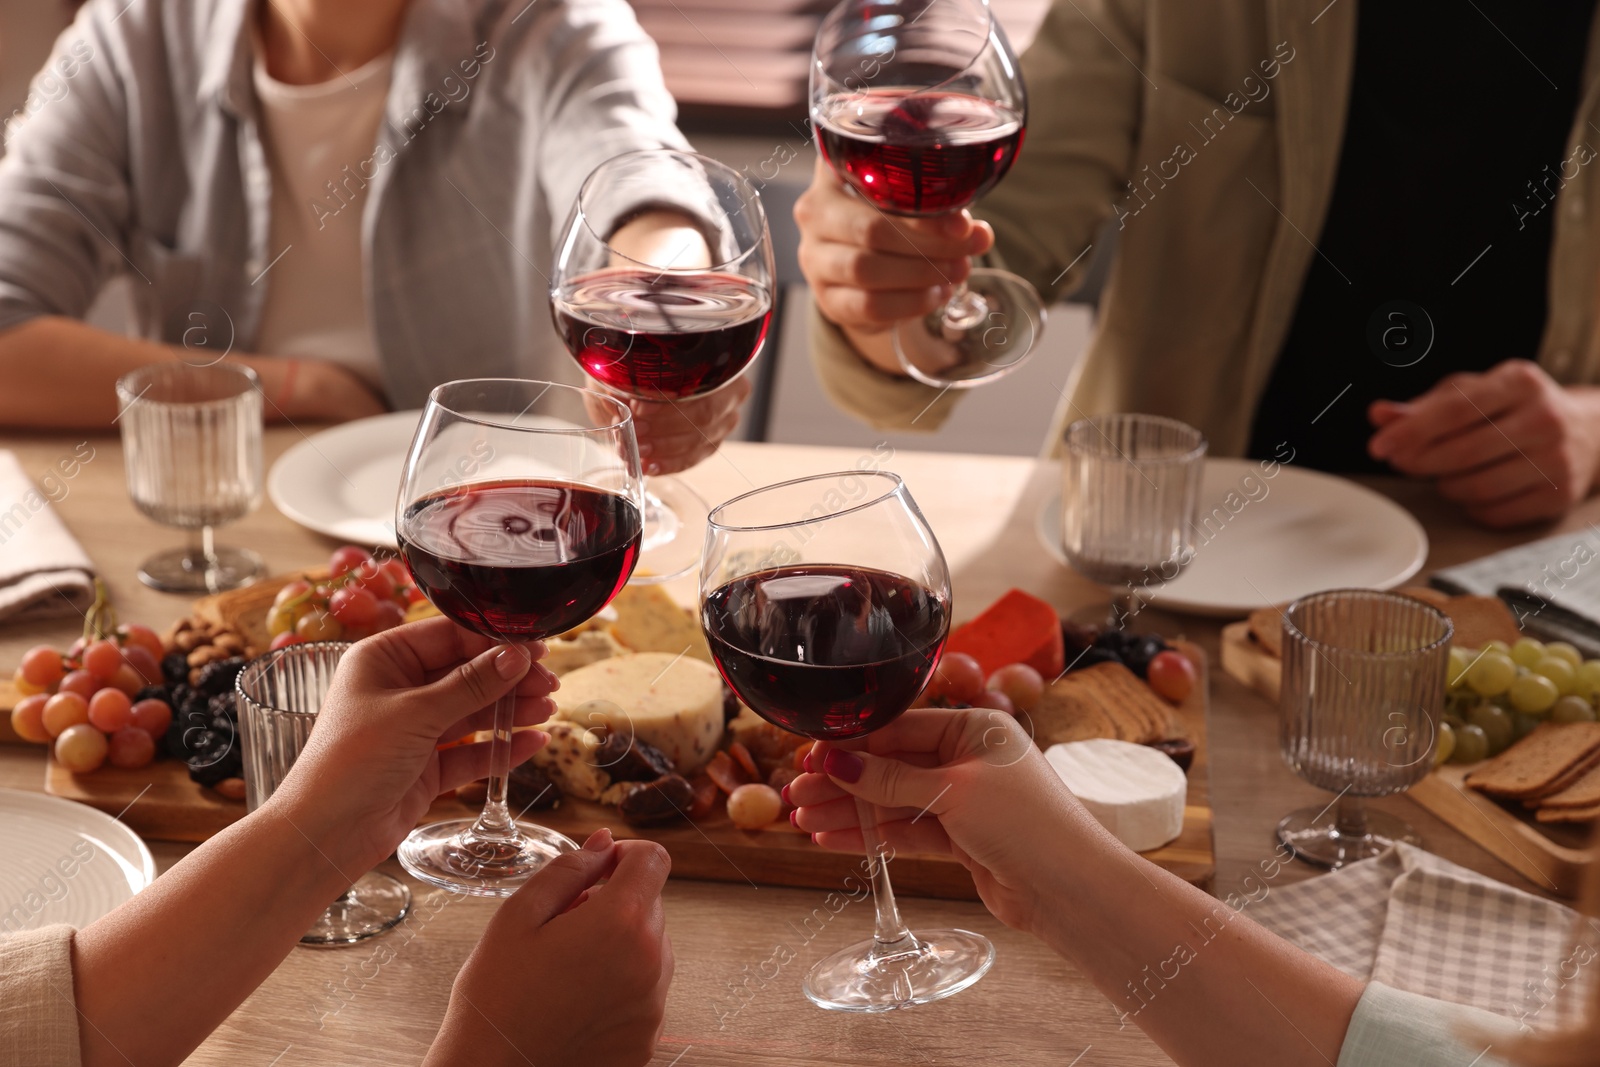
1037;459;1427;617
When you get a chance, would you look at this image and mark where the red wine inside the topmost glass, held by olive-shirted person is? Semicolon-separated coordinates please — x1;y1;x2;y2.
816;90;1022;214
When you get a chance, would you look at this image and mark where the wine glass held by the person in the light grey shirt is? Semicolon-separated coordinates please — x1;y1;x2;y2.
550;149;774;582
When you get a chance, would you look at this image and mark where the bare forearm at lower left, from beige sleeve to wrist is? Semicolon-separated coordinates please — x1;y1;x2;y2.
72;805;373;1067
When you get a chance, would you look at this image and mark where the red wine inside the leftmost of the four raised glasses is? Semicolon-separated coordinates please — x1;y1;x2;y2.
397;480;640;640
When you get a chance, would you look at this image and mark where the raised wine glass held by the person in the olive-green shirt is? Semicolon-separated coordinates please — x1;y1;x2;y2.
811;0;1045;389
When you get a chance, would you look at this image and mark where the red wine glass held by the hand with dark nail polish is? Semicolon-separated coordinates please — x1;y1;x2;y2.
701;470;994;1011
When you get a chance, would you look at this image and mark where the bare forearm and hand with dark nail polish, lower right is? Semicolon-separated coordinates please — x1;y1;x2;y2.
787;709;1362;1067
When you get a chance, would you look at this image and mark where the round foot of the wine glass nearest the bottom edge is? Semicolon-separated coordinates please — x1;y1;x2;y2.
805;929;995;1011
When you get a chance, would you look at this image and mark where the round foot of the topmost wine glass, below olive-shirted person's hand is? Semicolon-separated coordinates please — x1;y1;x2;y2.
894;267;1045;389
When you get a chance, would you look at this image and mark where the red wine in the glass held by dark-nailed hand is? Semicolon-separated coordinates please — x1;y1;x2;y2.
701;565;950;741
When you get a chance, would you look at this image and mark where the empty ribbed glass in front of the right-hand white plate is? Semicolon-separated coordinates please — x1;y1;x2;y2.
1061;414;1206;627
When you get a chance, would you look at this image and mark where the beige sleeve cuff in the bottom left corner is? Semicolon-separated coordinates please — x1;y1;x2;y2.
0;926;82;1067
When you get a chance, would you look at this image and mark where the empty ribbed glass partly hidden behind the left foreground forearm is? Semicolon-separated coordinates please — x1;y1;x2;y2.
234;641;411;945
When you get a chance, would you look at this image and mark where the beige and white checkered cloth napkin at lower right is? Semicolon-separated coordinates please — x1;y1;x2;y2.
1248;845;1600;1030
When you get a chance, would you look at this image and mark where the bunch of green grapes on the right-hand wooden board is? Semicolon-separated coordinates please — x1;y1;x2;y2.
1434;637;1600;766
